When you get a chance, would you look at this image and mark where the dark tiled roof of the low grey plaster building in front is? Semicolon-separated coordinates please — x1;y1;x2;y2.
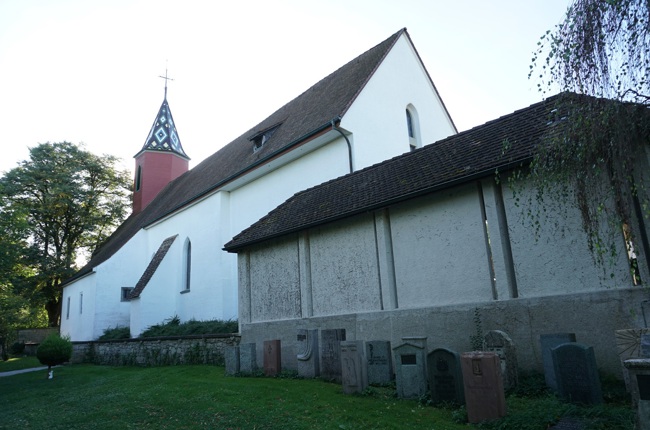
224;95;574;252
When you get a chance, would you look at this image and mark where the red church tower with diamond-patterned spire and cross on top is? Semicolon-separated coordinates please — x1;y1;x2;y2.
133;72;190;214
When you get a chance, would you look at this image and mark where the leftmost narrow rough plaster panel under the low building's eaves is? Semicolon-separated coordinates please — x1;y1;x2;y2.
250;237;300;321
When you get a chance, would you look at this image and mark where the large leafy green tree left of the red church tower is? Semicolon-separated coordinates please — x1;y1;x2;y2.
0;142;130;326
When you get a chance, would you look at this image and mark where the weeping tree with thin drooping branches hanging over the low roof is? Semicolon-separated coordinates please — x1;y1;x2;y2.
529;0;650;277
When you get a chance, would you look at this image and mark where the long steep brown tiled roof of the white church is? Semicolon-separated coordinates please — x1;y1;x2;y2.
64;29;408;285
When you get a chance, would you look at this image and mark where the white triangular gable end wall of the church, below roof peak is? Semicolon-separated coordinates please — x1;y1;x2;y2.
341;36;455;170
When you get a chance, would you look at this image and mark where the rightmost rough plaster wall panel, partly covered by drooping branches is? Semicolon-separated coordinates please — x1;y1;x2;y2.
503;176;632;297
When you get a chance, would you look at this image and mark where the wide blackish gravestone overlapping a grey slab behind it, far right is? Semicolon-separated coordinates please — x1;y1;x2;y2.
551;343;603;404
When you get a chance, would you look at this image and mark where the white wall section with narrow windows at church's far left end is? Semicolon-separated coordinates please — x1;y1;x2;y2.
60;273;97;340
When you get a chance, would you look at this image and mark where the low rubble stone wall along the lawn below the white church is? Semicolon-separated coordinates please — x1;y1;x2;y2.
71;334;239;366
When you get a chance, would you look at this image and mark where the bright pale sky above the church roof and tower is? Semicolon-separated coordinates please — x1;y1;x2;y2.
0;0;570;176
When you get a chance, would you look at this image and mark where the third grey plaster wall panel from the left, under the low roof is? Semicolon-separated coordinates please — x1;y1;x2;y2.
390;185;492;308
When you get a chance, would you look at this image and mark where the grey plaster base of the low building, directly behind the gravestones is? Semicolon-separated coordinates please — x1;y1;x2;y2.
241;288;647;378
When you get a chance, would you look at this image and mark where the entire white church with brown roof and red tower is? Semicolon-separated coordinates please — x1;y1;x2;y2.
61;29;456;341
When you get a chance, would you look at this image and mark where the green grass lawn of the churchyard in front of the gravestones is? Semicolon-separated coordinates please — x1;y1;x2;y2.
0;363;634;430
